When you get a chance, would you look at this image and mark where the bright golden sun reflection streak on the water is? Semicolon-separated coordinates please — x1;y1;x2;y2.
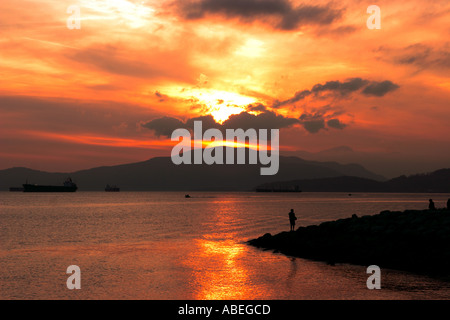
185;201;267;300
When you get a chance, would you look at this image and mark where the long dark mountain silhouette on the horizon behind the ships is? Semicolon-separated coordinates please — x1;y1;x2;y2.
0;148;384;191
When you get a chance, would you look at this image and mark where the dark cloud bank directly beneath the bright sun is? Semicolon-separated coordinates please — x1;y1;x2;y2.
142;110;299;137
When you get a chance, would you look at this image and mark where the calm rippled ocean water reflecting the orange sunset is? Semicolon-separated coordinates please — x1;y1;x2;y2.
0;192;450;300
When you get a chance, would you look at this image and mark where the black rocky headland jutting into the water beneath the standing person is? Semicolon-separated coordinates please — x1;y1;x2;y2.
248;209;450;279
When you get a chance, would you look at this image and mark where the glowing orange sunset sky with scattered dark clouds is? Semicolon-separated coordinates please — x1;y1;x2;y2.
0;0;450;174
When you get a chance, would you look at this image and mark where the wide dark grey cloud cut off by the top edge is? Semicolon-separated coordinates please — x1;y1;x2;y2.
177;0;342;30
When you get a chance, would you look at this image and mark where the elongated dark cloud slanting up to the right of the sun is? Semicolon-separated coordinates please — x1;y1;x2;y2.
272;78;399;108
